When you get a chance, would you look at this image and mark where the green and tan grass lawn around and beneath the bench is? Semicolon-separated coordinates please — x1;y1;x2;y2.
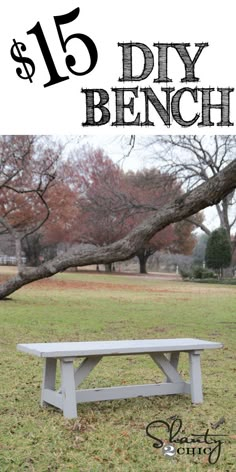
0;273;236;472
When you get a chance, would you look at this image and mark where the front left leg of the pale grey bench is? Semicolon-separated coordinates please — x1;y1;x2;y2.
61;359;77;418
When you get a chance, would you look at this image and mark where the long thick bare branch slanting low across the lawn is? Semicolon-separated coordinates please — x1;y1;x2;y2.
0;159;236;299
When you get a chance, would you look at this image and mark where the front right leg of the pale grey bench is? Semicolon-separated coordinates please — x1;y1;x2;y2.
189;351;203;403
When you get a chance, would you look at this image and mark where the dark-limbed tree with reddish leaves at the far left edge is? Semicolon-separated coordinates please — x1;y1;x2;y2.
0;136;59;270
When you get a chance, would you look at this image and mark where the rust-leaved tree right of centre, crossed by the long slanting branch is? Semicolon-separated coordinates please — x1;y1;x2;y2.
122;168;195;273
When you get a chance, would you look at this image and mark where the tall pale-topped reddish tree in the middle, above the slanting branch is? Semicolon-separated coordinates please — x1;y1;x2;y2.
67;147;130;271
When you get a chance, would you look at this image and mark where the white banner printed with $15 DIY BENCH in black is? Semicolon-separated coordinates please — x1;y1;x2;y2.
0;0;236;135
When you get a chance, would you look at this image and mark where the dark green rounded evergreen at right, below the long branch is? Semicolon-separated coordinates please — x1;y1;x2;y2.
205;228;232;277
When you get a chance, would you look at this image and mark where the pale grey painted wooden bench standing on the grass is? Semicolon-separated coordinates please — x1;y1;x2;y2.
17;339;222;418
